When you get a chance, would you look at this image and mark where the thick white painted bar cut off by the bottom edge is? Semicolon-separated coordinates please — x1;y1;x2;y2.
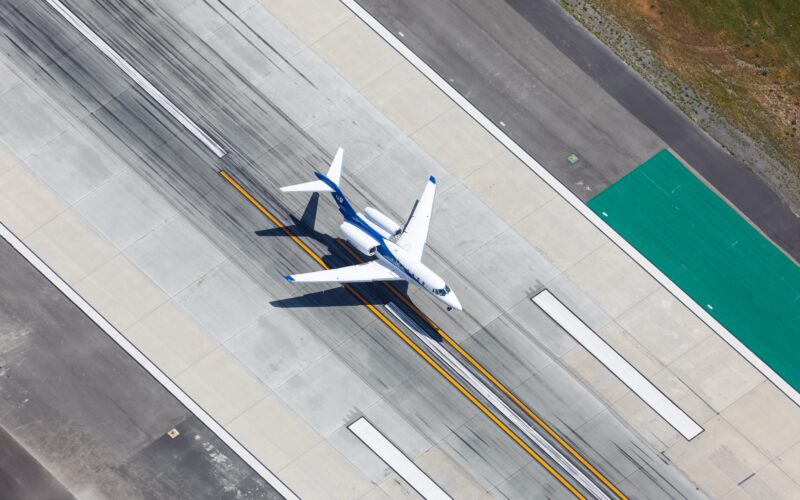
347;417;452;500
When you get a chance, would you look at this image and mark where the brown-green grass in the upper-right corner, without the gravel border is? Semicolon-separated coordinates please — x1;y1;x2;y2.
588;0;800;186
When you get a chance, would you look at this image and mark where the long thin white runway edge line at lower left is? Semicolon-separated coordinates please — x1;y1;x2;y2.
0;222;299;500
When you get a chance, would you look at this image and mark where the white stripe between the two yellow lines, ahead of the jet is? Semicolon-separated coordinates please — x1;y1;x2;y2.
386;302;610;500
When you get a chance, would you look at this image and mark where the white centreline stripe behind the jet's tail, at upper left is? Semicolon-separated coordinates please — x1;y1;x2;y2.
46;0;226;158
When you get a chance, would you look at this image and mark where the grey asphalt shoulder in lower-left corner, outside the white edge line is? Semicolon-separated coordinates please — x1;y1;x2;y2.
0;241;281;500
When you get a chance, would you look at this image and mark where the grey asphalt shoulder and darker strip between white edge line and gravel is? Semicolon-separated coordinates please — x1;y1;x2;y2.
359;0;800;261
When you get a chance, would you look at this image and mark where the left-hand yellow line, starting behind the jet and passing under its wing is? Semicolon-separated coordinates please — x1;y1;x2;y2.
219;170;586;500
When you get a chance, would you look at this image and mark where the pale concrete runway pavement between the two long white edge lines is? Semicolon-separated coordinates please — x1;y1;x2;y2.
0;0;792;498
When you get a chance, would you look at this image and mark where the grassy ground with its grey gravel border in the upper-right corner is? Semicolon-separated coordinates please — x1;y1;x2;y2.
561;0;800;213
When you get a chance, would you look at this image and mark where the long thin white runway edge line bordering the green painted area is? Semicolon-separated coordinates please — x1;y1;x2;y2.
340;0;800;406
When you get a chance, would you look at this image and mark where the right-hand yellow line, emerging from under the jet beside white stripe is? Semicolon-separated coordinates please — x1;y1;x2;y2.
336;238;628;500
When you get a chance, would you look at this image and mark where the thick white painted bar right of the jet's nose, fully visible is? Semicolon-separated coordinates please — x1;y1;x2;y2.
531;290;703;439
